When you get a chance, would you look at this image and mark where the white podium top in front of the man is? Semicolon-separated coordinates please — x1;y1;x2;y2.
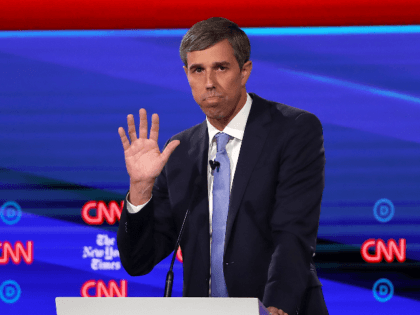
55;297;269;315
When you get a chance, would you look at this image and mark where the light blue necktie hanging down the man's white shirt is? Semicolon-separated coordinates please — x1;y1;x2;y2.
211;133;230;297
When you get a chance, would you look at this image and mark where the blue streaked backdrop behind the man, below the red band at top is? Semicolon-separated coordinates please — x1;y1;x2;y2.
0;26;420;315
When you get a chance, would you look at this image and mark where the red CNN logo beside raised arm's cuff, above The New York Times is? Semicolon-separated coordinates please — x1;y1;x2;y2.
82;200;124;225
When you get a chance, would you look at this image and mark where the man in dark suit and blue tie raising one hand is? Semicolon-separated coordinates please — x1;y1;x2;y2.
117;18;328;315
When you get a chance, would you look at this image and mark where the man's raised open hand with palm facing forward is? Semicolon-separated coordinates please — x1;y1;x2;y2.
118;108;180;203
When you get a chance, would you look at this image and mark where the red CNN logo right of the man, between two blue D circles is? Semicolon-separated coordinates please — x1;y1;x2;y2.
360;238;407;263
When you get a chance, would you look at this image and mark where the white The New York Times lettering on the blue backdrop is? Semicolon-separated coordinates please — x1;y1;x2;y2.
82;234;121;270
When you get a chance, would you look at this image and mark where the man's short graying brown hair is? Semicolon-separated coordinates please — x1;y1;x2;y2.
179;17;251;69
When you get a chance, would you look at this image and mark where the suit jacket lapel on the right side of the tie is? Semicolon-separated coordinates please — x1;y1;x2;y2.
224;93;271;252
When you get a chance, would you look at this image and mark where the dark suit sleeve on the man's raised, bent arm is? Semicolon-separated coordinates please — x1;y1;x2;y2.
117;146;176;276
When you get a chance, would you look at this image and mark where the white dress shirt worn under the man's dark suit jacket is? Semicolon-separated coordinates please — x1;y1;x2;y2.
126;94;252;296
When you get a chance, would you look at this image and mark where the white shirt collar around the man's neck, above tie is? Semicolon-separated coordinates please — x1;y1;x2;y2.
206;93;252;146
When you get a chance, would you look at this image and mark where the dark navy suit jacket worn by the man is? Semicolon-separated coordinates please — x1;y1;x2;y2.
117;93;325;315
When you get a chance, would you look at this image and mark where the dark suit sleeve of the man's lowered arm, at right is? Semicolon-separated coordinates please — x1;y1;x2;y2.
263;113;325;315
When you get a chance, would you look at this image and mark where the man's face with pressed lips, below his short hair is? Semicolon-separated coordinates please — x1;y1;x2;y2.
184;39;252;125
